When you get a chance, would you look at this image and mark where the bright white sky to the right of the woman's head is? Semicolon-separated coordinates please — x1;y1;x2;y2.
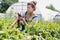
19;0;60;20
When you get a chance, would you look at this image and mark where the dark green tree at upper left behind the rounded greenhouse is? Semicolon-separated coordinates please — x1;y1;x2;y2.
0;0;18;13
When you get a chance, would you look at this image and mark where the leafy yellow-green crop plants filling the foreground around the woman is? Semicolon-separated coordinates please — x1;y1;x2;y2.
0;18;60;40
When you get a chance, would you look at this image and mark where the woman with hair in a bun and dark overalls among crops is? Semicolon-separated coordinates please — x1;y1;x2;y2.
9;1;39;31
